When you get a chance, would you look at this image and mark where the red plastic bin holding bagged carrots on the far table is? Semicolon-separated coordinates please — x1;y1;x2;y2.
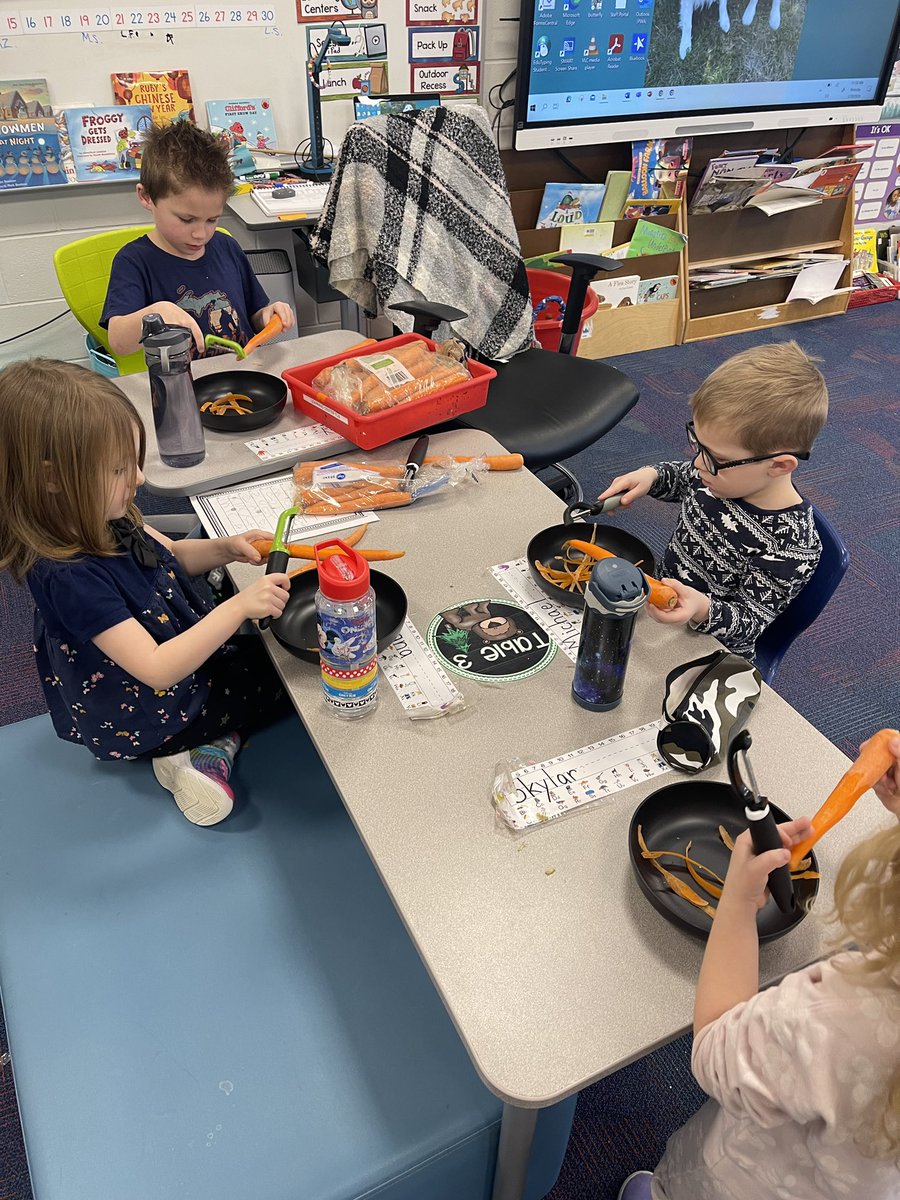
281;334;497;450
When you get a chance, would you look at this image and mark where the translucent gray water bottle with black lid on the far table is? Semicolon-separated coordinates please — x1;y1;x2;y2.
140;312;206;467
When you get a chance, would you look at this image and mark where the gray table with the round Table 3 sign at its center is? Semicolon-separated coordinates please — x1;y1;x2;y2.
229;431;882;1200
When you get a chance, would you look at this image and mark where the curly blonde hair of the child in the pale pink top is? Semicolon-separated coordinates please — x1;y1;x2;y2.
834;822;900;1162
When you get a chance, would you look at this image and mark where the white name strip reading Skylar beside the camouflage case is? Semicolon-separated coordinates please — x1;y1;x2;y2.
493;721;672;830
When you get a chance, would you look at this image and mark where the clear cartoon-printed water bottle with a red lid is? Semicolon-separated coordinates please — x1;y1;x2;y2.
316;539;378;720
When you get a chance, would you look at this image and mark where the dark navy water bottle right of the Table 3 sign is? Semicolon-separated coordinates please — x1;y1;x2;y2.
572;558;650;713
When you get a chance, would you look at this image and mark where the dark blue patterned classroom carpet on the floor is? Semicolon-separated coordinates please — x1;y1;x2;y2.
0;302;900;1200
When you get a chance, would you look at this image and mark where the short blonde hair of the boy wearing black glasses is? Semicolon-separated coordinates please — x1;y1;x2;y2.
691;342;828;455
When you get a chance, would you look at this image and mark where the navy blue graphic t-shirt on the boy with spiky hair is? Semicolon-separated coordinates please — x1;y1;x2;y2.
100;232;269;346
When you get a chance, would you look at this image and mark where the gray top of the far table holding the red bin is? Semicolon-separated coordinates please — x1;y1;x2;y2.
115;329;361;496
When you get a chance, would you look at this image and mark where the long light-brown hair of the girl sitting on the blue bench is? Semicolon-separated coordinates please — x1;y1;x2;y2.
0;359;145;582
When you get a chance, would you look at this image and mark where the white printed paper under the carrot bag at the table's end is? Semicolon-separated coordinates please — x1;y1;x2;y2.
191;472;378;542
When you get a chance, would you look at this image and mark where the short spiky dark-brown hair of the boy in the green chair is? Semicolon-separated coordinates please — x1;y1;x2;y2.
140;121;234;204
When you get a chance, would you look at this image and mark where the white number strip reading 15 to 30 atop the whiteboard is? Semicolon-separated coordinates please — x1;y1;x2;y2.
0;4;275;36
